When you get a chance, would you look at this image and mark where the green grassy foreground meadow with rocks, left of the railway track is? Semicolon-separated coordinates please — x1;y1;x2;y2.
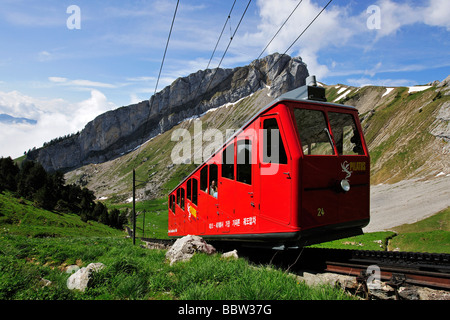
0;194;353;300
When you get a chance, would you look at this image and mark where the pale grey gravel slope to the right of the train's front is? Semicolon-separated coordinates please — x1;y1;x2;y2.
363;174;450;232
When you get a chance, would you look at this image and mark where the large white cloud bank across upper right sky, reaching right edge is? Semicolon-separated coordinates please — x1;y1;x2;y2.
250;0;450;81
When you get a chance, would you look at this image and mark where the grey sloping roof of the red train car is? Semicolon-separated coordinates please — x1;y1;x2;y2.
169;85;357;193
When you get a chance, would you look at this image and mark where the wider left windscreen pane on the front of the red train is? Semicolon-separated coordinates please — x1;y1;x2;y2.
294;109;334;155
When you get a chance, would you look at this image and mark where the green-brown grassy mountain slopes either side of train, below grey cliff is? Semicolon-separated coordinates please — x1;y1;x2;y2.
66;75;450;202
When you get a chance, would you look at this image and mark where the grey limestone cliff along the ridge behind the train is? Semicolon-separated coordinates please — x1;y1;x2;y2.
27;54;308;171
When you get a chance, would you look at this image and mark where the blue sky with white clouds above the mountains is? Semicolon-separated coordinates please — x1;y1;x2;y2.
0;0;450;157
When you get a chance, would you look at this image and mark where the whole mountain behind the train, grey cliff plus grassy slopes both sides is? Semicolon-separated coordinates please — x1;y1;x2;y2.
19;54;450;202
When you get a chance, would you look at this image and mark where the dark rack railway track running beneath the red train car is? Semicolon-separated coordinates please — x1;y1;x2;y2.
142;238;450;291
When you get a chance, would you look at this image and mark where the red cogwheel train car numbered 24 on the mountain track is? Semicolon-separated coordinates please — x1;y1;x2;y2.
168;79;370;247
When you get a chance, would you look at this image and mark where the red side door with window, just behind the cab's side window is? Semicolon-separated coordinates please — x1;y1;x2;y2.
231;136;256;230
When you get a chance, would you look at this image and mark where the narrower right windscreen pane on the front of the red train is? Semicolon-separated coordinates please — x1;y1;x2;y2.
328;112;364;155
